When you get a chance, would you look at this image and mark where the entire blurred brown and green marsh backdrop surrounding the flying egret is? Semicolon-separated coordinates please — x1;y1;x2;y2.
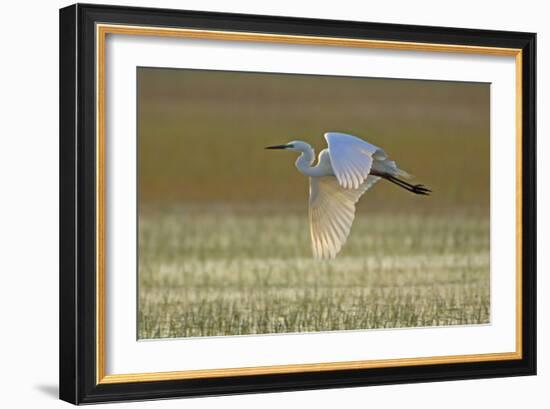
137;68;490;338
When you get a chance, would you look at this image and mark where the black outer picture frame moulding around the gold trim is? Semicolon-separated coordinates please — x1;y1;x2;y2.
59;4;536;404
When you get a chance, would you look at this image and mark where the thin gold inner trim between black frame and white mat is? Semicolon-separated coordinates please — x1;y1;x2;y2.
96;24;522;384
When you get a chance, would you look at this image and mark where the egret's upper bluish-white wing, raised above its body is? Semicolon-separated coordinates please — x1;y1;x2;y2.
325;132;386;189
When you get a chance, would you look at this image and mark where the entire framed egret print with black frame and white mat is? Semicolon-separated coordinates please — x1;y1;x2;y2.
60;5;536;404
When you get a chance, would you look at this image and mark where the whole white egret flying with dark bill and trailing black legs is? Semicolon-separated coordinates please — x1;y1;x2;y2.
266;132;431;259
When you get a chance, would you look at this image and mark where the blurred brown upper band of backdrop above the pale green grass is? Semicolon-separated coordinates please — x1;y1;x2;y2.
138;68;490;211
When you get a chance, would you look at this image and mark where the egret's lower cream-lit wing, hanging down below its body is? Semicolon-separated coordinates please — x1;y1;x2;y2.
309;175;380;259
